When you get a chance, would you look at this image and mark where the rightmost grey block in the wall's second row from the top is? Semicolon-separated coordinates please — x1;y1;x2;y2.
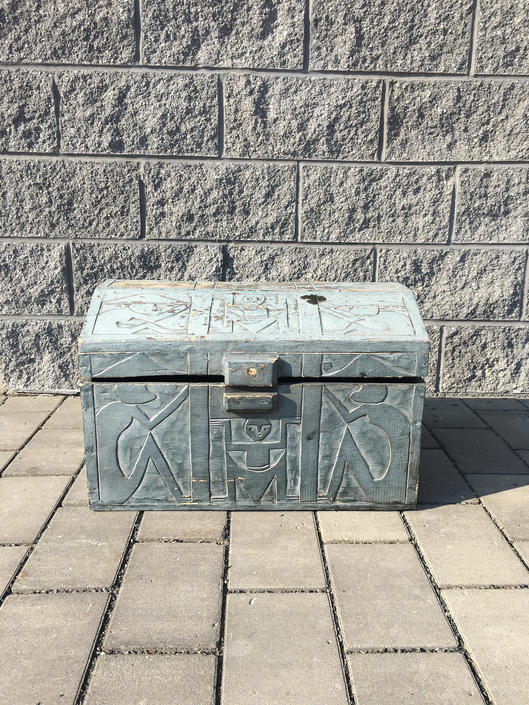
386;80;529;160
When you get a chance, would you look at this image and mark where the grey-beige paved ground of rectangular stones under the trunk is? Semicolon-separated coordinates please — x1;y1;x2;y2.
0;396;529;705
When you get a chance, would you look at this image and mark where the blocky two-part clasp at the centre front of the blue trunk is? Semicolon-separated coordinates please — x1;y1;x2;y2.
222;355;278;412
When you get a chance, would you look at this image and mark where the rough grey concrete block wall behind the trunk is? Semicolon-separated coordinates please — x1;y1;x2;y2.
0;0;529;395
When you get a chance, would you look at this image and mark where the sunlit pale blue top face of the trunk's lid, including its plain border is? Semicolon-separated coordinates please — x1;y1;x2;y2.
80;281;429;354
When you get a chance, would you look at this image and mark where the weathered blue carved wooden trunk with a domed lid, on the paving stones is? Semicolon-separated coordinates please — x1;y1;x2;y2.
80;281;429;511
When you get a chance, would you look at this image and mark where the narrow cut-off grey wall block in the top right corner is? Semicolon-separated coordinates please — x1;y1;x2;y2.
476;0;529;74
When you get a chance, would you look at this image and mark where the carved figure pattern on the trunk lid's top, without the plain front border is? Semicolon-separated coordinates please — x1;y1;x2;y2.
90;289;415;339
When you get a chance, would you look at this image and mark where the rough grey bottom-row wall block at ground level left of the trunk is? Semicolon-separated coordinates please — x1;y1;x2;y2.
0;319;82;392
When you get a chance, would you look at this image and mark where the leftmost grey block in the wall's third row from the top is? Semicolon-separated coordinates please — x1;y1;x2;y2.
0;159;140;241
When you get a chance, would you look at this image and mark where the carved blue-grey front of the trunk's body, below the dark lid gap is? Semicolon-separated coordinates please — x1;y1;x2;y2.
83;381;422;509
